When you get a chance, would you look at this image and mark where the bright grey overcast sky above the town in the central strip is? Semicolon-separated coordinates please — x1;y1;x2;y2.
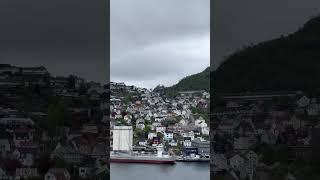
110;0;210;88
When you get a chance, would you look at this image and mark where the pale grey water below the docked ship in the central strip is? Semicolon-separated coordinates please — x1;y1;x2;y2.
110;162;210;180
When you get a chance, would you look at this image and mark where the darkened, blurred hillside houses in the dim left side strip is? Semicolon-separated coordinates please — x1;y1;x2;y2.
0;64;110;180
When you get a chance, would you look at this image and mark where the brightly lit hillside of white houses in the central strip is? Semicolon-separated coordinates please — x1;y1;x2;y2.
110;82;210;161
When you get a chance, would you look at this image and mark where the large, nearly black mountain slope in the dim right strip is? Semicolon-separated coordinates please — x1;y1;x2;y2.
211;16;320;93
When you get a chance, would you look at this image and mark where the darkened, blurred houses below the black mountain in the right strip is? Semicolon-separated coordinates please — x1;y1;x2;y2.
210;91;320;180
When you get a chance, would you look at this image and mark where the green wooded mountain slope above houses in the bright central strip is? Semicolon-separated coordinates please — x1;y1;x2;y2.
154;67;210;95
